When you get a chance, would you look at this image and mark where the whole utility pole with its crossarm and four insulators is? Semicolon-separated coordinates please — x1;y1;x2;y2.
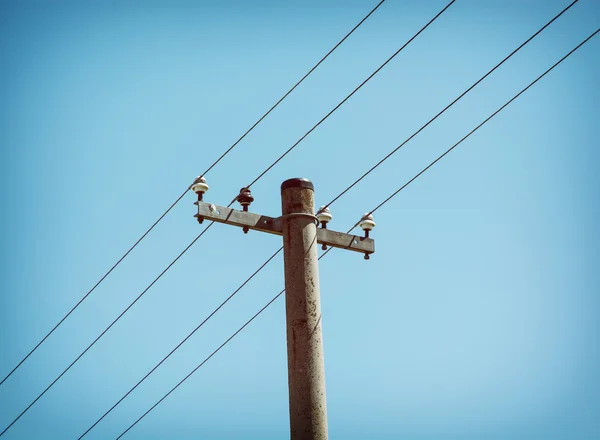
191;177;375;440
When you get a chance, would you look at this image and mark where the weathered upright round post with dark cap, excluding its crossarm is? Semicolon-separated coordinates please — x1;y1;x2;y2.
281;179;327;440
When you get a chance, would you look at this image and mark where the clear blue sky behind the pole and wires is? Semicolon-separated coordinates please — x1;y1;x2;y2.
0;0;600;440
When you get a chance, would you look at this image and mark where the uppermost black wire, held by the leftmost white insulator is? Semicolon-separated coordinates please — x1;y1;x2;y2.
0;0;385;386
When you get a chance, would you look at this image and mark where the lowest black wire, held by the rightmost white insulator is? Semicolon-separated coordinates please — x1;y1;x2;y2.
117;29;600;440
